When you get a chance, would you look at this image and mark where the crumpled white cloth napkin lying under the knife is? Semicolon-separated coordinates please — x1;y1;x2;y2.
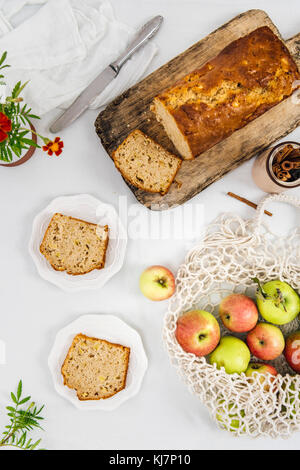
0;0;157;116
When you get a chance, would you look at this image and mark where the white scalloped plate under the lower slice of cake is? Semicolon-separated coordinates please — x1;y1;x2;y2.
48;315;148;411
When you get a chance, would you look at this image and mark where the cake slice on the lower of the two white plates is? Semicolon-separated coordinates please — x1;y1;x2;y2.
61;333;130;400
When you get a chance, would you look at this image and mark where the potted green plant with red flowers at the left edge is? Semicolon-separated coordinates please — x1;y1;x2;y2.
0;52;64;167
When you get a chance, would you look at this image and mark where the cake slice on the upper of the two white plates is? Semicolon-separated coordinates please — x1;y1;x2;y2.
40;213;108;275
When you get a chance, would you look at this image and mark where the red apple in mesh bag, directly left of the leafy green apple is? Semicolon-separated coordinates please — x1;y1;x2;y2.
219;294;258;333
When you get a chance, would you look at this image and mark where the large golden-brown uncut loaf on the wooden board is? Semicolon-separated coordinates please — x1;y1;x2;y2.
151;27;300;159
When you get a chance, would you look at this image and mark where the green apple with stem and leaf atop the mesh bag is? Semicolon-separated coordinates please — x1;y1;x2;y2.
253;278;300;325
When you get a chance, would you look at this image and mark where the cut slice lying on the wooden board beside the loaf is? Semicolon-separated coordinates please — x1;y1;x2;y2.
112;129;182;195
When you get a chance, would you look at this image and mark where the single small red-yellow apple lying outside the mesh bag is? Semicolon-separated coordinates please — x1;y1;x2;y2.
140;266;175;300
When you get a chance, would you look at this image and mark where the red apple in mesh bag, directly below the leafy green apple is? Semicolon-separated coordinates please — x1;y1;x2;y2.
247;323;284;361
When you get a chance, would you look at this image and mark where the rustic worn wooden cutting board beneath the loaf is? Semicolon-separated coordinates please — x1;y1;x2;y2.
95;10;300;210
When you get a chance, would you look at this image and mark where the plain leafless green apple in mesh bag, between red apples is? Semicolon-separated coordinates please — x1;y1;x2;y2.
209;336;250;374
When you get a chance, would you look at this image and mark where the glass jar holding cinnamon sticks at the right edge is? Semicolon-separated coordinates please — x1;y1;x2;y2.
252;141;300;193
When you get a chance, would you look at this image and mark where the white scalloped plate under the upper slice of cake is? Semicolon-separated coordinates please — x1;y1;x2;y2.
29;194;127;292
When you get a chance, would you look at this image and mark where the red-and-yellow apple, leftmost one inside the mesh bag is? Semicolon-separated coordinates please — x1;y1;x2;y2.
175;310;220;356
